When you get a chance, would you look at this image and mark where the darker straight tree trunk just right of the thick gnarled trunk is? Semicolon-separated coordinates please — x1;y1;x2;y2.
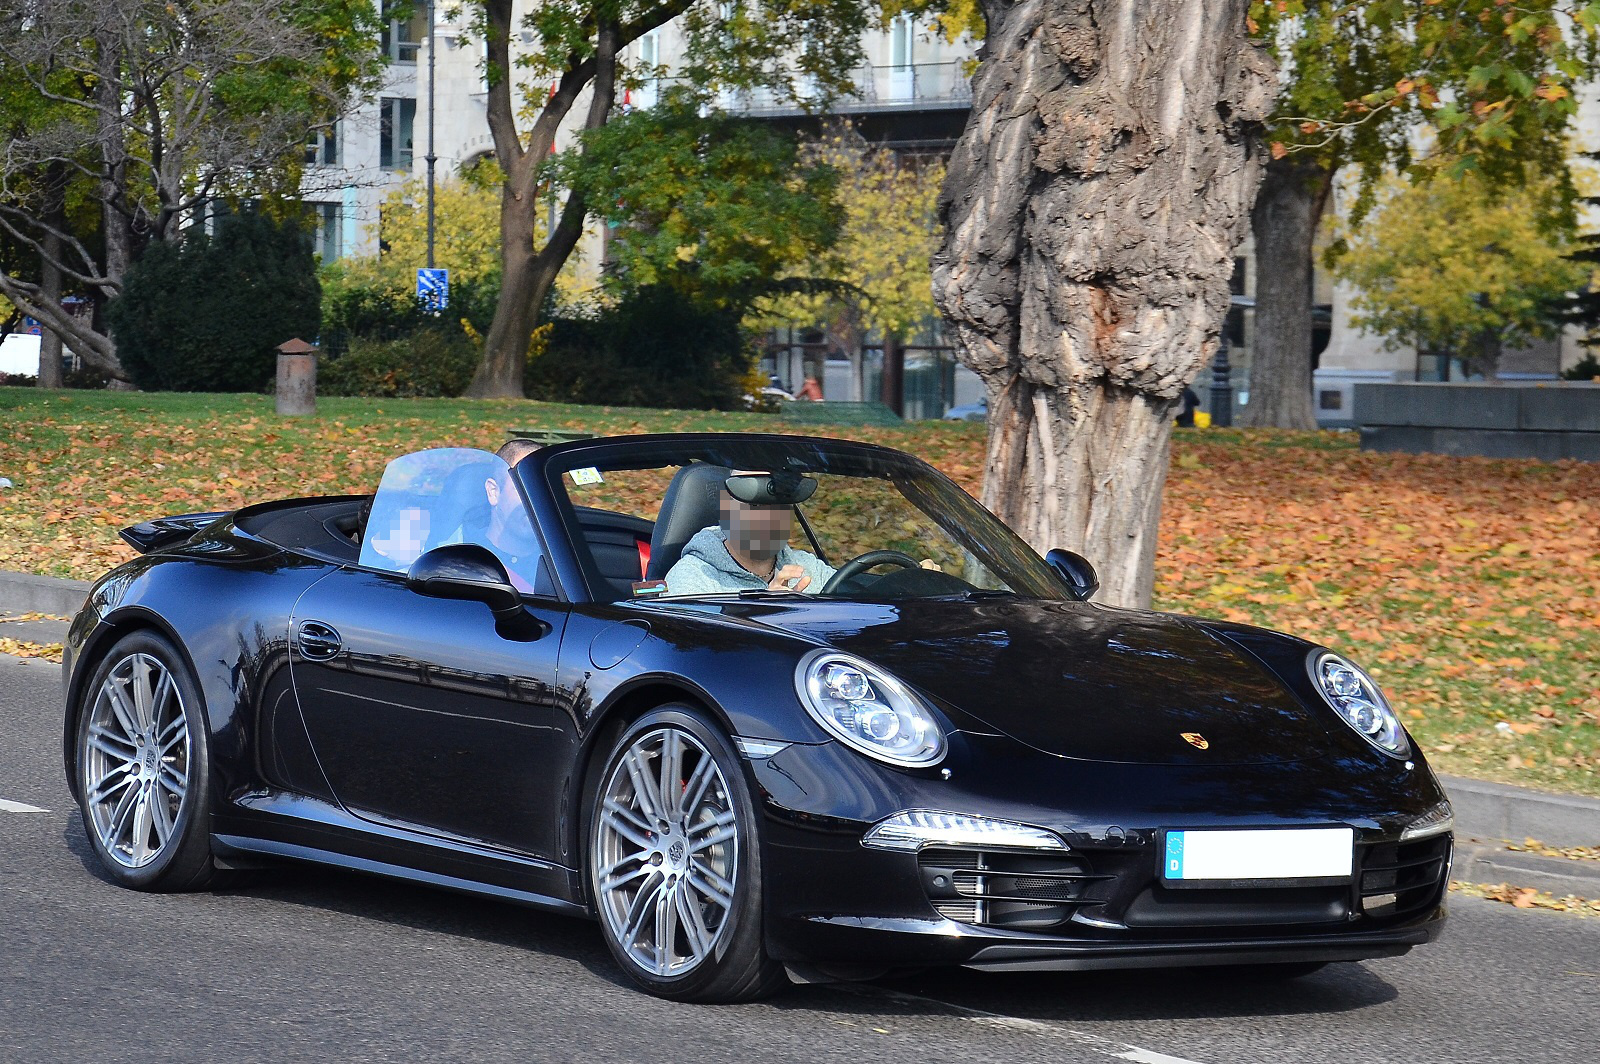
1240;158;1333;429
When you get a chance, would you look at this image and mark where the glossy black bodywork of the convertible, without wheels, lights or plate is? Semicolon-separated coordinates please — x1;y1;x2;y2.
64;435;1451;968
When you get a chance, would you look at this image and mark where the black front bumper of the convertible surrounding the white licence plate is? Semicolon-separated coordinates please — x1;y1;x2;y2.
754;736;1451;970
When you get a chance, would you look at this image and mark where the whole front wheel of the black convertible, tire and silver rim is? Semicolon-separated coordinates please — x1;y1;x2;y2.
589;706;784;1002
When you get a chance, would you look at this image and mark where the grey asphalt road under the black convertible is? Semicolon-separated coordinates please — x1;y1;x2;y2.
0;656;1600;1064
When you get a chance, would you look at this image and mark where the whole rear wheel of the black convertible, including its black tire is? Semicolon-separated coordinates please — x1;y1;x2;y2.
74;630;216;893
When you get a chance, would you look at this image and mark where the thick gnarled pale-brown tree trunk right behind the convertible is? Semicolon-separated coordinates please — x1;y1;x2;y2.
934;0;1274;606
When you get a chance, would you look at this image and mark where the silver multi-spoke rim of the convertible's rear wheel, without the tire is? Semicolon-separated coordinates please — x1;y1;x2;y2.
80;653;189;869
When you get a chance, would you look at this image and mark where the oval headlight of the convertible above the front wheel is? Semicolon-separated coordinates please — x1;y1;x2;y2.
795;650;944;768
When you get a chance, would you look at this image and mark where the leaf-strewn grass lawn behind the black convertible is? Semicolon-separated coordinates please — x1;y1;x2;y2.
0;389;1600;795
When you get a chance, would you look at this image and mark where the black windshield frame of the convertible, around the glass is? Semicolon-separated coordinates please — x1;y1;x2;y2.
524;432;1070;603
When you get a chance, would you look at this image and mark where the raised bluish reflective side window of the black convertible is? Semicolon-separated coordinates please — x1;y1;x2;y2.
360;446;541;594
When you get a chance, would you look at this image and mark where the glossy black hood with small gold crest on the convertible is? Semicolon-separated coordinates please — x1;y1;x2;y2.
672;598;1333;766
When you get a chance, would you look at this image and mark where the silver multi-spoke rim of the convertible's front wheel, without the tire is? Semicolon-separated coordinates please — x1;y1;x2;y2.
594;726;739;976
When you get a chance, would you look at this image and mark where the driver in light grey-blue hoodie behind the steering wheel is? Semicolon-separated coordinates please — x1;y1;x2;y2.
667;473;834;595
